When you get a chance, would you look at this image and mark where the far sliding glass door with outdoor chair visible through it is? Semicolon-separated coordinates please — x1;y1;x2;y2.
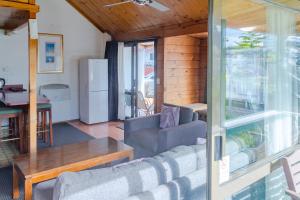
124;40;156;117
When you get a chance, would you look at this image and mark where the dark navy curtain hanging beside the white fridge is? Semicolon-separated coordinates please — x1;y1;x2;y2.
105;41;119;121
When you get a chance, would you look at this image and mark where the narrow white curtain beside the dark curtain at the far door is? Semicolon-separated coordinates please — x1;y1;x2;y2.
118;42;125;120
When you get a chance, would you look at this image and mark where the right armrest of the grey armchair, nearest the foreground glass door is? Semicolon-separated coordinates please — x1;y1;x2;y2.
158;120;207;153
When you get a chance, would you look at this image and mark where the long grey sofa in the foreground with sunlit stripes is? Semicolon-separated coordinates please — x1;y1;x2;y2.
33;145;206;200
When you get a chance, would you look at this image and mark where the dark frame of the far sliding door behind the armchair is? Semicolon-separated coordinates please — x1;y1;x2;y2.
124;38;157;118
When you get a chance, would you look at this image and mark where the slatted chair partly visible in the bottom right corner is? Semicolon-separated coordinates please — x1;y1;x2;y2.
281;149;300;200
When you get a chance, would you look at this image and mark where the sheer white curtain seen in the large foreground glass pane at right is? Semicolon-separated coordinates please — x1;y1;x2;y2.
264;7;298;155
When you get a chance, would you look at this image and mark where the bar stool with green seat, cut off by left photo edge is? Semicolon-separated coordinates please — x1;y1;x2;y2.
0;107;25;153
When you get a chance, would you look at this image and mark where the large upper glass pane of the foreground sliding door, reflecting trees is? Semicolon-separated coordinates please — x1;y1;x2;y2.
220;0;300;177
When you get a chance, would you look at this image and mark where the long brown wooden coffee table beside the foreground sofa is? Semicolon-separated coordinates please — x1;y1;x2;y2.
12;138;133;200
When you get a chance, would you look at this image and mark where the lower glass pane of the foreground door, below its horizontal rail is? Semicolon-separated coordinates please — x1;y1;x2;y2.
226;168;291;200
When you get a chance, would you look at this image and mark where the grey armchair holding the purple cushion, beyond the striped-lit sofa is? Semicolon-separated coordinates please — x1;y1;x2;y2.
124;104;207;158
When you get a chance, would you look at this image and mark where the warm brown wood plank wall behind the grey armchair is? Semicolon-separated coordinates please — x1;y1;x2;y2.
163;36;207;105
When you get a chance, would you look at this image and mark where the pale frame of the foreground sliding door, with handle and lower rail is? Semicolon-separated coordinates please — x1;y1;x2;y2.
207;0;300;200
